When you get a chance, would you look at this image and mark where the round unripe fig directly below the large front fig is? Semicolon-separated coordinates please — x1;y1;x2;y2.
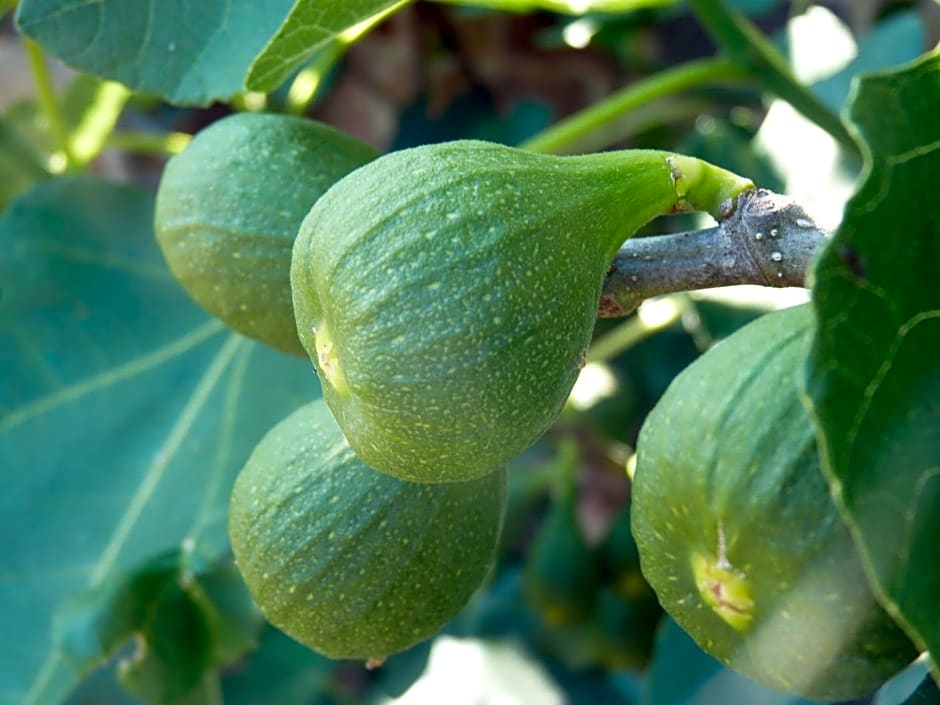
229;400;506;660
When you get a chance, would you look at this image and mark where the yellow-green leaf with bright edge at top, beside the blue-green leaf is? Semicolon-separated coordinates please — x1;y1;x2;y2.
245;0;410;91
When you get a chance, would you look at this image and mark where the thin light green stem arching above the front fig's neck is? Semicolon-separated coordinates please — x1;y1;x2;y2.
519;57;746;153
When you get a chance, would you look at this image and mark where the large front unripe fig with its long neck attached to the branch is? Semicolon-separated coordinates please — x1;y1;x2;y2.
291;141;750;482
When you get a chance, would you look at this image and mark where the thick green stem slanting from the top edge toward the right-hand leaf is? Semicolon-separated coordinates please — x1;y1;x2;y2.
690;0;859;155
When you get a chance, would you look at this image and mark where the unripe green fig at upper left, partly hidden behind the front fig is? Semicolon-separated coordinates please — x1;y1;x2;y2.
154;113;377;355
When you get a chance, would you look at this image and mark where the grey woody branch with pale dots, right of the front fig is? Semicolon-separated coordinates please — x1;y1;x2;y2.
598;189;829;318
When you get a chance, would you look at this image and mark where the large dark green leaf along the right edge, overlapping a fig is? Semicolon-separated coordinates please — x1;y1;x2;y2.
806;51;940;676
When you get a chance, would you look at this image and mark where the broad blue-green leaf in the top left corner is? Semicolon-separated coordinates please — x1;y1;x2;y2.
16;0;291;105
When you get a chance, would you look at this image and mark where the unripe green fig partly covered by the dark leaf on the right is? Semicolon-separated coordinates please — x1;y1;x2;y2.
633;305;916;700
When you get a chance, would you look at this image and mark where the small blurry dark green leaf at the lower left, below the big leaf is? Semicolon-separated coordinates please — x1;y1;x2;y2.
53;551;262;703
